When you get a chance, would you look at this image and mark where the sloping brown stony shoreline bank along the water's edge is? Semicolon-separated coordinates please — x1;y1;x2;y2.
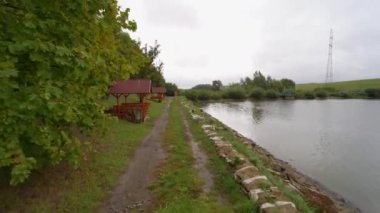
198;107;361;213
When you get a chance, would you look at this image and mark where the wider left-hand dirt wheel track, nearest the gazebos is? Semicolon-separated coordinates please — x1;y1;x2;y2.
99;99;171;213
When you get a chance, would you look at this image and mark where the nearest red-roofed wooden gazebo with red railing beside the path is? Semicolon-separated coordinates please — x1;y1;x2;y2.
108;79;152;122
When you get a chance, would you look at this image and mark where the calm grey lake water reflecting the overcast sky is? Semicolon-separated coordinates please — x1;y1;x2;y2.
203;100;380;213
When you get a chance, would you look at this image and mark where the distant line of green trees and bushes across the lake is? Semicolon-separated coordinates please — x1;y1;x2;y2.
183;71;380;101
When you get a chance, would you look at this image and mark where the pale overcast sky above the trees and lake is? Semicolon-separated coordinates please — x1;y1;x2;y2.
119;0;380;88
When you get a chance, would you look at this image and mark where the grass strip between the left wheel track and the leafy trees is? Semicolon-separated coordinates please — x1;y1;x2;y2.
0;99;165;212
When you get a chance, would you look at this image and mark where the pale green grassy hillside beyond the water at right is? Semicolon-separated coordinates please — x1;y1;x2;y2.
296;78;380;91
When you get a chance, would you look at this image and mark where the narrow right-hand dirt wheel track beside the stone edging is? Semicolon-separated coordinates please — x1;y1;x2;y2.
181;112;214;194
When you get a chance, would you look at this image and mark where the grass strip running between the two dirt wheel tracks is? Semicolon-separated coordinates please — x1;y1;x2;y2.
152;100;231;213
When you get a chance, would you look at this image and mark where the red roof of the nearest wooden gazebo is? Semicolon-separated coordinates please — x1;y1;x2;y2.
108;79;152;94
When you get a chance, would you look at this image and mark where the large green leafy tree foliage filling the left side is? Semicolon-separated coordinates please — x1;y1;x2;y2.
0;0;147;185
